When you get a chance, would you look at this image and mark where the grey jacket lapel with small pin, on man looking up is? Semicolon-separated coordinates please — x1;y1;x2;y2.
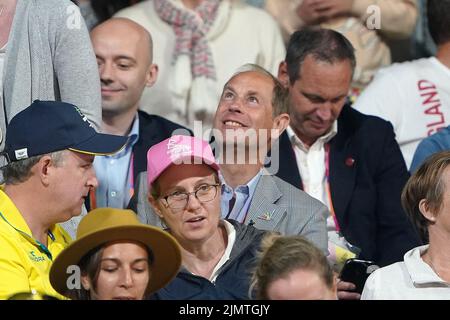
245;174;286;230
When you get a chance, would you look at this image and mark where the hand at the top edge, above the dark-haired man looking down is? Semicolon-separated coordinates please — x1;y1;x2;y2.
297;0;354;24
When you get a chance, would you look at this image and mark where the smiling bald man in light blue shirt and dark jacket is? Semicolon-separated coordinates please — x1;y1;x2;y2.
86;18;190;209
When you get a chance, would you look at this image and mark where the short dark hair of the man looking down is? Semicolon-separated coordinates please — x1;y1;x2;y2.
285;27;356;83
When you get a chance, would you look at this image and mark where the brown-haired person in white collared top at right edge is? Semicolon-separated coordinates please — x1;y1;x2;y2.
362;151;450;300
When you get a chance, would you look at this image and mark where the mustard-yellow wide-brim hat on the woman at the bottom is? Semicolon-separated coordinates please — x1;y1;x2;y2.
50;208;181;296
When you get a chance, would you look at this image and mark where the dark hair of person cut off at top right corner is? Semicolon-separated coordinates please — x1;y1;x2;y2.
427;0;450;45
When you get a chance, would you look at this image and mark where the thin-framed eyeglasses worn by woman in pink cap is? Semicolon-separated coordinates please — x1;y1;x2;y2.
162;183;220;209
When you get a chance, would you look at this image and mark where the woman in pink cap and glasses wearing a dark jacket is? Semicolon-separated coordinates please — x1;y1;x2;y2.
147;136;266;300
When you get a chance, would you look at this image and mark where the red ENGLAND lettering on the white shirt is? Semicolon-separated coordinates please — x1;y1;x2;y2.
417;79;446;136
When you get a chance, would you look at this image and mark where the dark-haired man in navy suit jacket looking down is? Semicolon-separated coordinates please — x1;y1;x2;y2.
277;28;419;298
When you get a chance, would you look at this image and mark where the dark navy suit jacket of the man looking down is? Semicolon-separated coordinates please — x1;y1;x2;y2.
277;105;420;266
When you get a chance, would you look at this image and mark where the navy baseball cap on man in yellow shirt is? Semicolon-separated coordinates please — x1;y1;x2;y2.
3;100;128;162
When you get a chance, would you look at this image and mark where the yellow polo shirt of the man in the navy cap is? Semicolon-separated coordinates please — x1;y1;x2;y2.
0;189;71;299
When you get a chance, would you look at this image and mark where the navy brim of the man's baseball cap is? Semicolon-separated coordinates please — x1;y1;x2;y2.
68;133;128;156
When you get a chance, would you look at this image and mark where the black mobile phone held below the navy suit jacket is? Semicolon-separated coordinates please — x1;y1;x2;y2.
339;259;379;293
